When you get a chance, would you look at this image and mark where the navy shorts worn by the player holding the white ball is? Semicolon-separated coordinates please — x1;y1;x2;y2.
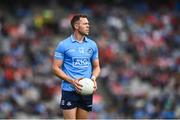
60;91;93;111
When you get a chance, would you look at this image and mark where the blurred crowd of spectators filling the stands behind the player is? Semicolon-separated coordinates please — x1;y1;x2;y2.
0;0;180;119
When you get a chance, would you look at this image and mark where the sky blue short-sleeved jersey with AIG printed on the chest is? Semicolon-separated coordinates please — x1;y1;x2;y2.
54;35;98;91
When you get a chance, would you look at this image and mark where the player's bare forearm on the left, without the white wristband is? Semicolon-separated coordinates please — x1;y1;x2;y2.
53;67;73;83
